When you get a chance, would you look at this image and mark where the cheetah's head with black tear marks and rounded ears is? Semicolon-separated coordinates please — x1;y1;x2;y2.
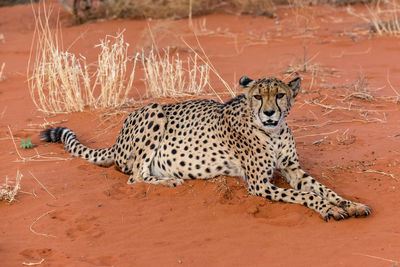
239;76;300;131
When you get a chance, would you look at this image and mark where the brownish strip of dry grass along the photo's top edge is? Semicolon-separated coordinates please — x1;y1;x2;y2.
66;0;287;22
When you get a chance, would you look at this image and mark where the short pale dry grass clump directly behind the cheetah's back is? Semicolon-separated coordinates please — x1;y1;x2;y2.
142;48;210;97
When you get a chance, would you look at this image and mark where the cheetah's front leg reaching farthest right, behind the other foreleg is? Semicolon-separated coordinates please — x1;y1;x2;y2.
281;162;371;217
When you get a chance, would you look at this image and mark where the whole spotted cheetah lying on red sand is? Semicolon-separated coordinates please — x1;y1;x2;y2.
40;76;370;221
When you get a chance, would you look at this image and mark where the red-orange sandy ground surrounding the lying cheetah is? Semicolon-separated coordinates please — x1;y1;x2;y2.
0;1;400;267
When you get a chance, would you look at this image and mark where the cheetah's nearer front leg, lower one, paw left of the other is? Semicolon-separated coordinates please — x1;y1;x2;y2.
249;176;348;221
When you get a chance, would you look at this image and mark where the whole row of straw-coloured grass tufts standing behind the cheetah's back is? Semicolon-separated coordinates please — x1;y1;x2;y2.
27;4;234;114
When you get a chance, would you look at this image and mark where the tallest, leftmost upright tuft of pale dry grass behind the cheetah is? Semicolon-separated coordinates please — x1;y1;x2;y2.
27;8;93;113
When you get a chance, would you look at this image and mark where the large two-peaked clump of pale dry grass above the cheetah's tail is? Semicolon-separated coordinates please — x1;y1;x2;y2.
27;8;137;114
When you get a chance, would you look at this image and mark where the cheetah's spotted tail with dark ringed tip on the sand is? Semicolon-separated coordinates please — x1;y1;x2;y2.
40;127;115;167
